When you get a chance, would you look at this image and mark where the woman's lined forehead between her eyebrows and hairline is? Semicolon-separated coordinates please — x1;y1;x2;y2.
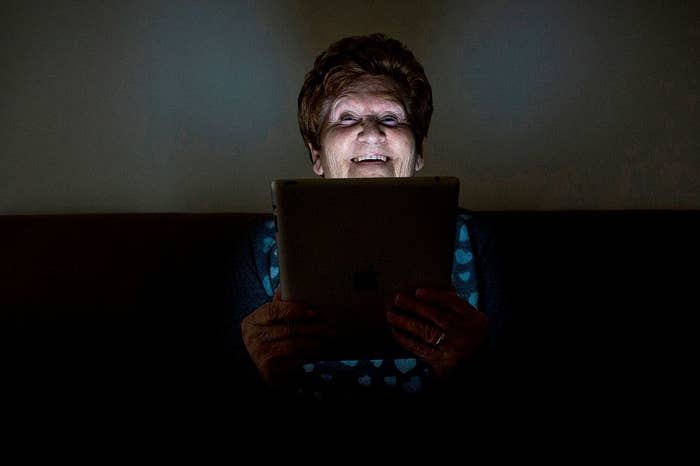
330;76;403;113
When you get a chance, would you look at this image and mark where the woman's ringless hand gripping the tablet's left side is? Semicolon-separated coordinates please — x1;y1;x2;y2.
241;289;335;387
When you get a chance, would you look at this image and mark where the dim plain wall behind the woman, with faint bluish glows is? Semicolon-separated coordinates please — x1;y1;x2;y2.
0;0;700;214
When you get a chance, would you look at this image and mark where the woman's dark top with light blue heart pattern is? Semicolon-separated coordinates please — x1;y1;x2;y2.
253;214;479;398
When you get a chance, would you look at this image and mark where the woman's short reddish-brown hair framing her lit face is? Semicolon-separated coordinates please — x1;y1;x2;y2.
297;34;433;158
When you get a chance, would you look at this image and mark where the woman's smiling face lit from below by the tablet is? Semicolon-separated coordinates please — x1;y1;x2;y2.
309;76;423;178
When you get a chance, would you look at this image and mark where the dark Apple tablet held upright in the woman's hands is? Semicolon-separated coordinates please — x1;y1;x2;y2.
272;176;459;358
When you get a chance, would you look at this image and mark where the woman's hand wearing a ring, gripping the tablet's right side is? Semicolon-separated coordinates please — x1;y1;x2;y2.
387;288;488;377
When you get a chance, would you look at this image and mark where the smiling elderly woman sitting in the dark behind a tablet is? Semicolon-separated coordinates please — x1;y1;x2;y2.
241;34;497;396
